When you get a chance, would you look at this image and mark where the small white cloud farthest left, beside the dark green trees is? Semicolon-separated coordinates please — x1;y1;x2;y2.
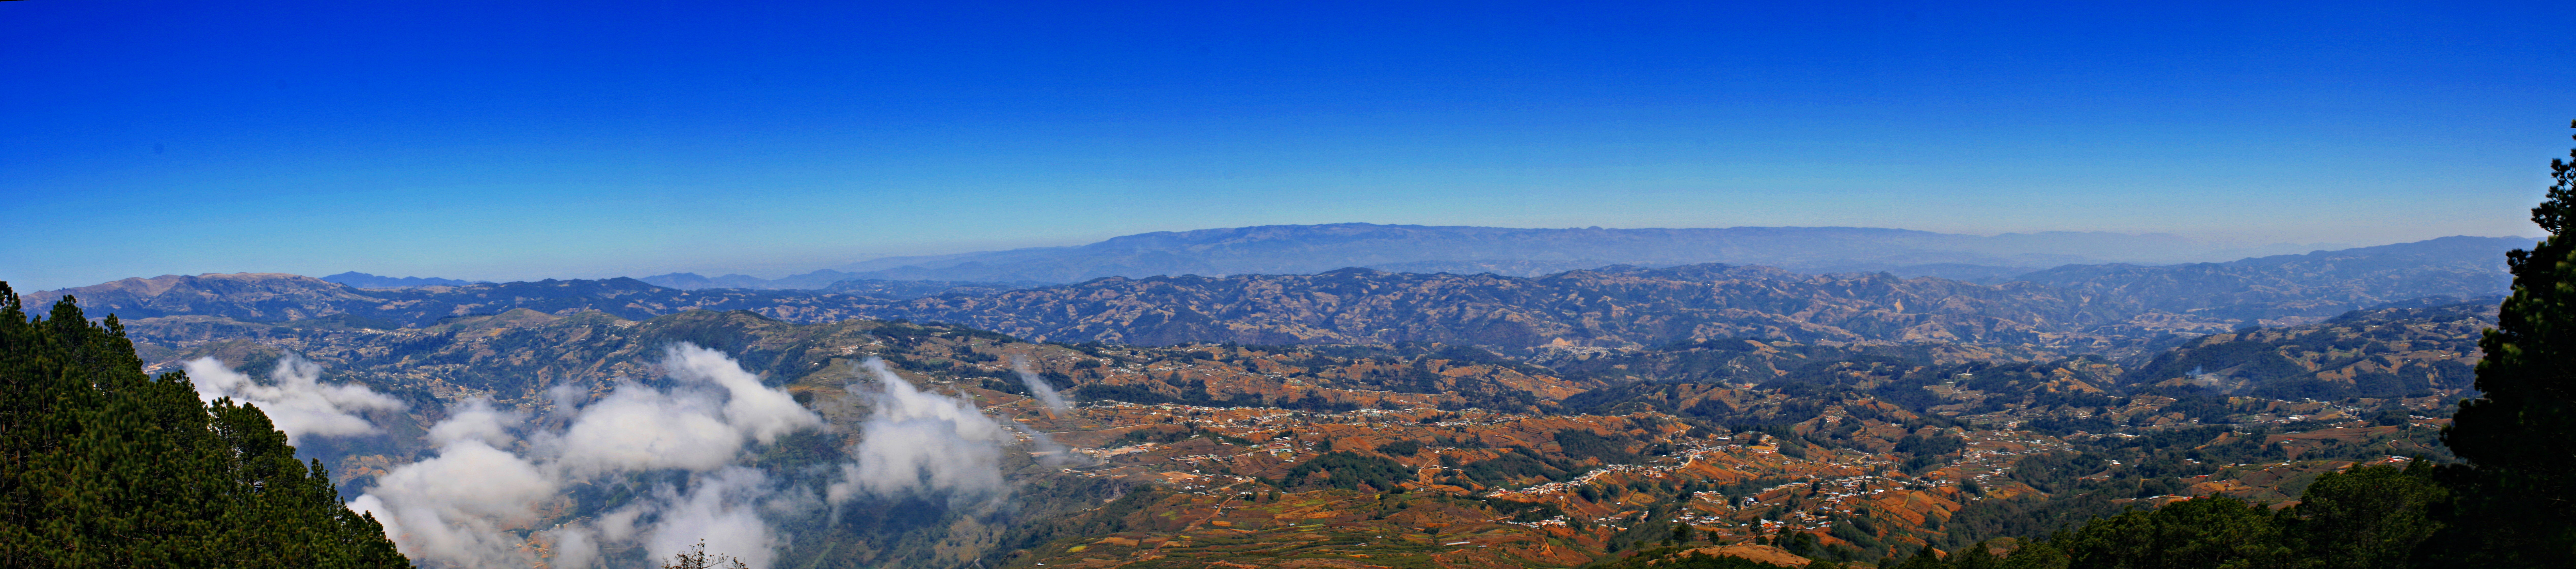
185;353;404;443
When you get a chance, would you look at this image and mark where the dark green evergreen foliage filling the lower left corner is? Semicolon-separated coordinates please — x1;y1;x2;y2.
0;283;410;566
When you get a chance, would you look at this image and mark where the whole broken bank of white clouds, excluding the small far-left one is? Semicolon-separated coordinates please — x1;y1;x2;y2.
350;345;1043;569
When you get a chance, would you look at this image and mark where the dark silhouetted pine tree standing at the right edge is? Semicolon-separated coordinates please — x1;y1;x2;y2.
2437;121;2576;566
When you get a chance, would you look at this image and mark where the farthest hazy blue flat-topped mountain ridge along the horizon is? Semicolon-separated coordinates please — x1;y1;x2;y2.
814;224;2359;283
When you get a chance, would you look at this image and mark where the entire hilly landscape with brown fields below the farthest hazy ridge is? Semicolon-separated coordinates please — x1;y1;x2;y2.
21;229;2527;569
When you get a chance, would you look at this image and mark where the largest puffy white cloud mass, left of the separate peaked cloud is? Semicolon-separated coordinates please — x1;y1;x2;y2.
353;345;824;569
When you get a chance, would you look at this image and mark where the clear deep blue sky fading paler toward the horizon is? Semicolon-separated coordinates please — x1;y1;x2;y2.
0;0;2576;291
